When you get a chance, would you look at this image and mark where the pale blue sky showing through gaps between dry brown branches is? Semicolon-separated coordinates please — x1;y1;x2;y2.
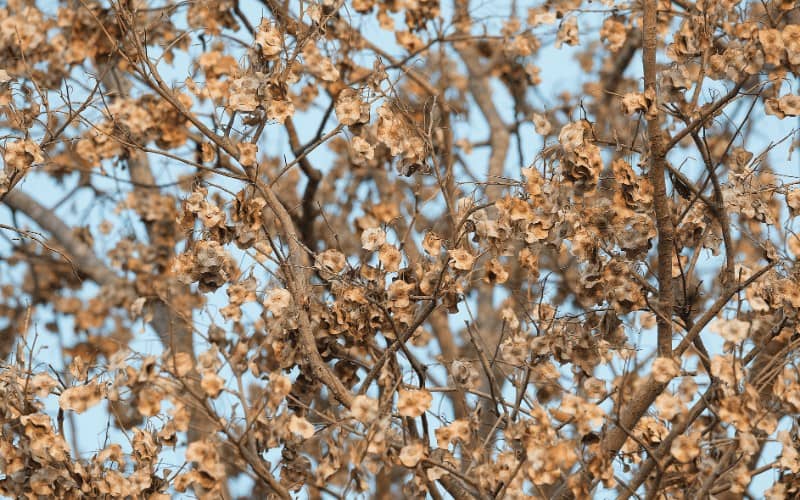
0;2;800;498
